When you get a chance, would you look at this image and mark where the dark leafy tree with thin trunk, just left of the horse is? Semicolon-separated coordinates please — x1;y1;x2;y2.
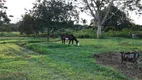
32;0;77;40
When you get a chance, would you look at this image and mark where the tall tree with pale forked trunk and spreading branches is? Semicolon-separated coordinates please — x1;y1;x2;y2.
77;0;142;38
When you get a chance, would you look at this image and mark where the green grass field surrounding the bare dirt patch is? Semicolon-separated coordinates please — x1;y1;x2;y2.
0;37;142;80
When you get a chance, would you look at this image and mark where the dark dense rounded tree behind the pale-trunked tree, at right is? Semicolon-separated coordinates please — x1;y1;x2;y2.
103;6;132;31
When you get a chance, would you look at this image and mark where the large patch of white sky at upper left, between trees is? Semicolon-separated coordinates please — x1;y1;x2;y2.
5;0;36;22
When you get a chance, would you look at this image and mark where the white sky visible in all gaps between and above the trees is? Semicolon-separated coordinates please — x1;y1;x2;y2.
5;0;142;25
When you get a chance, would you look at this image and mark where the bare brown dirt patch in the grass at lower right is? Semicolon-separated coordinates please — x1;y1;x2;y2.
93;52;142;80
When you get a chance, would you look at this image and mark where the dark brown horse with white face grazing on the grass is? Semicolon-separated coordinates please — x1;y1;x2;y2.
61;34;79;46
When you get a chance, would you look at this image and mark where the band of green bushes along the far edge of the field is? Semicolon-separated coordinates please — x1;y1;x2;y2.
0;23;142;38
